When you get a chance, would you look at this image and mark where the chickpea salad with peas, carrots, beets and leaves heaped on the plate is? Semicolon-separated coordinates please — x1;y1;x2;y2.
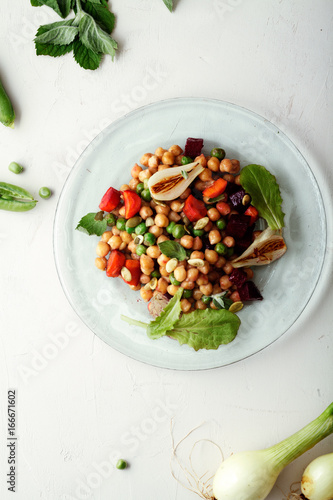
76;138;287;351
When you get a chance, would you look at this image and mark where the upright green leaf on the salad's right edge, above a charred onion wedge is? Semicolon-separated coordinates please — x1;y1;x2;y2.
240;165;284;230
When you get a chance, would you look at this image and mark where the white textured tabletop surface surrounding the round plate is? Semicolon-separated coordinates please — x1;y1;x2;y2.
0;0;333;500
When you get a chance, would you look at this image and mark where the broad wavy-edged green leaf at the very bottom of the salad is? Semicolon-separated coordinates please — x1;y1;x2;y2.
167;309;240;351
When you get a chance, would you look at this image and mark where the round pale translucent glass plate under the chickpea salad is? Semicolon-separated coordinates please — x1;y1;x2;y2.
54;98;326;370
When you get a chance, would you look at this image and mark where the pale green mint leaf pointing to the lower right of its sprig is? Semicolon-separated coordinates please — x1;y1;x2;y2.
79;14;117;59
